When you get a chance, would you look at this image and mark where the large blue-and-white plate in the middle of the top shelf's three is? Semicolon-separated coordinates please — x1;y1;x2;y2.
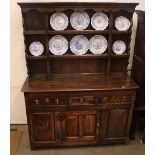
70;12;90;30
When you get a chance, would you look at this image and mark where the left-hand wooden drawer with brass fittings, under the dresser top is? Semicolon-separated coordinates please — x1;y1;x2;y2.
30;97;66;105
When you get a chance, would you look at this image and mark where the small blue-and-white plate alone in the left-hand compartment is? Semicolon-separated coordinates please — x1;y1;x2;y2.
29;41;44;56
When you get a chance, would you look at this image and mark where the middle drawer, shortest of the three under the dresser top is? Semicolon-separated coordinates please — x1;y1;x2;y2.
69;96;95;105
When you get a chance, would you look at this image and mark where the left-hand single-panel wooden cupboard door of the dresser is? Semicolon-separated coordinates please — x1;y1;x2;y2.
31;113;55;142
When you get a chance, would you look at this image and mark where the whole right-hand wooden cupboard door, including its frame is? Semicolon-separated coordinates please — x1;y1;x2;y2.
100;109;129;141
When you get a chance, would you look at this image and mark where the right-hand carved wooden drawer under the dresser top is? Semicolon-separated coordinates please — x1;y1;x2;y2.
99;95;131;103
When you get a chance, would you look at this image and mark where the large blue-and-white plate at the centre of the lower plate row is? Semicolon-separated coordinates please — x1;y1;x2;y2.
70;35;89;55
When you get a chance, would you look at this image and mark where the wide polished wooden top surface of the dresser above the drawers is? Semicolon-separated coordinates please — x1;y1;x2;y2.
22;74;138;92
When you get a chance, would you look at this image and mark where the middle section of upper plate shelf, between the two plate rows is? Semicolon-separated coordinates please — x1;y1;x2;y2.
48;30;109;34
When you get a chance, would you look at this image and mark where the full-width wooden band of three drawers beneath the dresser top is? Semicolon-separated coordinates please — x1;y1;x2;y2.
28;91;133;105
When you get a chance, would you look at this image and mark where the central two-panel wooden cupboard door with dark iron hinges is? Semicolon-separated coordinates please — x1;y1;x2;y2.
57;111;99;145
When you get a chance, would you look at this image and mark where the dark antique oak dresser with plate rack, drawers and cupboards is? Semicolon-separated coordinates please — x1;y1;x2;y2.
18;2;138;149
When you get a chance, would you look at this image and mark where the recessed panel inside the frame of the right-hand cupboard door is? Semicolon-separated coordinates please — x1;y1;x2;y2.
107;109;128;138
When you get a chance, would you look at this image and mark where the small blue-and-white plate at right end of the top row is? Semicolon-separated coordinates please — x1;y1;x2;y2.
115;16;130;31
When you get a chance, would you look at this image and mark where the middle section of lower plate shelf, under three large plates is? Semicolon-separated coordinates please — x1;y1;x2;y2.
49;54;108;59
